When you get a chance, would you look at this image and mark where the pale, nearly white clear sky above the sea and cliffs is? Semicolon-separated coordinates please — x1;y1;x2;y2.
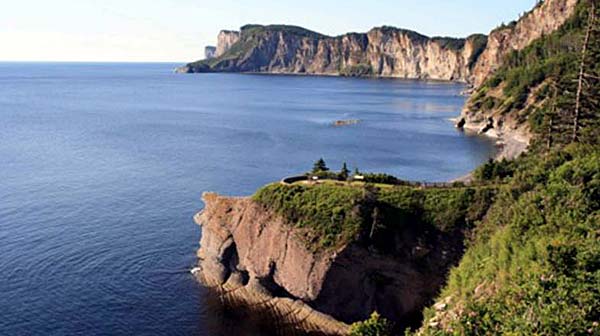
0;0;535;63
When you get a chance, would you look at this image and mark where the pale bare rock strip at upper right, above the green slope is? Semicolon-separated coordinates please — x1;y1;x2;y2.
472;0;578;86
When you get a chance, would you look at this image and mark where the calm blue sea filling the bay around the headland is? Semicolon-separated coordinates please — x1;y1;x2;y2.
0;63;494;336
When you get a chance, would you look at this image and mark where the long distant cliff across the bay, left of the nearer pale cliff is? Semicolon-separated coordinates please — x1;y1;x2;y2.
187;26;485;82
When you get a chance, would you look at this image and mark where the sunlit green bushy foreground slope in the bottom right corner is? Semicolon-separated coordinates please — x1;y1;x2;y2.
425;144;600;335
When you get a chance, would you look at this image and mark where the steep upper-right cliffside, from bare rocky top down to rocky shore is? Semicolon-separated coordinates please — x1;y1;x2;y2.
459;1;593;154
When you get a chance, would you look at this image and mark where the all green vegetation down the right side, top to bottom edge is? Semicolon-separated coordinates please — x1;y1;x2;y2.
421;1;600;335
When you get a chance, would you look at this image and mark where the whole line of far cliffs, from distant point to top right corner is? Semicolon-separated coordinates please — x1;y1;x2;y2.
179;0;578;86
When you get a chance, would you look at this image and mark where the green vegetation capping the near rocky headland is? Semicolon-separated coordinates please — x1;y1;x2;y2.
254;183;495;250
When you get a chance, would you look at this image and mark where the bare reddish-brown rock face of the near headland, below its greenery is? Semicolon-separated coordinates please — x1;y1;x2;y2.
195;193;463;334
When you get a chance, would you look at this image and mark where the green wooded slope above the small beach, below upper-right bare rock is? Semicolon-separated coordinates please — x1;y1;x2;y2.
469;1;600;147
